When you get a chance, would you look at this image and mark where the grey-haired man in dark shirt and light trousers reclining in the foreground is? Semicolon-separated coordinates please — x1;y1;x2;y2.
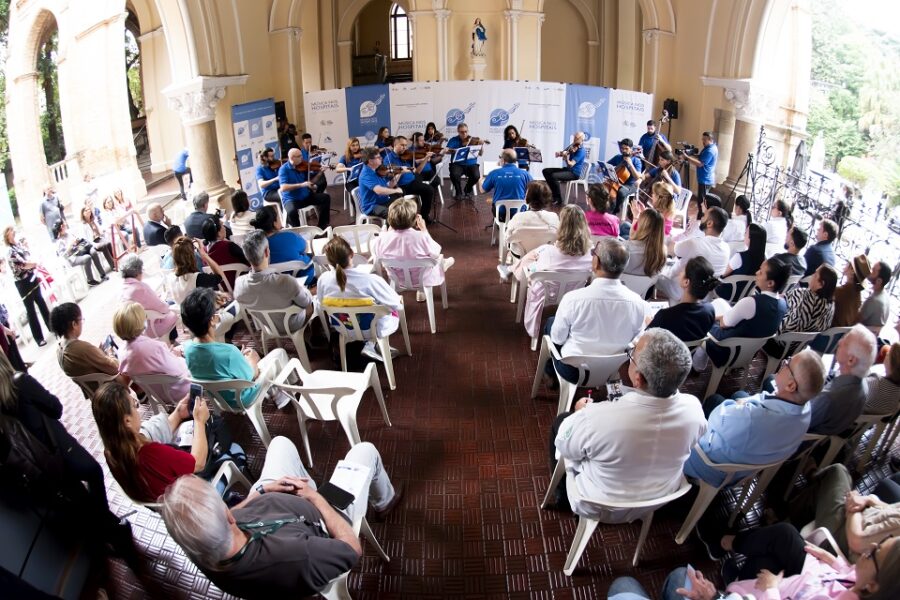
162;437;402;599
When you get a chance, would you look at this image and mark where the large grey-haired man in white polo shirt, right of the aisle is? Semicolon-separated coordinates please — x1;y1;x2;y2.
550;328;706;523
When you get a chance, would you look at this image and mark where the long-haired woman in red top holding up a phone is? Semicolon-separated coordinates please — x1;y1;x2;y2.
91;382;212;502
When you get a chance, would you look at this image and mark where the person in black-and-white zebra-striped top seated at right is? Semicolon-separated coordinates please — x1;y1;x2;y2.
763;264;837;356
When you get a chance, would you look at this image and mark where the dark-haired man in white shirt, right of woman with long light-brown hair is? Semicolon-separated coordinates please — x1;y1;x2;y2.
656;206;731;305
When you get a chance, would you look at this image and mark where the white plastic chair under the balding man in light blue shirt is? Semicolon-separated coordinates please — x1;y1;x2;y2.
675;446;784;545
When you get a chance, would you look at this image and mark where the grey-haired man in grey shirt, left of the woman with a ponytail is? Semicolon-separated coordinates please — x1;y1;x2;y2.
234;230;314;333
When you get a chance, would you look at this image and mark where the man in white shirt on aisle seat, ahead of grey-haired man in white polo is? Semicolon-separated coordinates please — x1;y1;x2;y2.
544;237;649;382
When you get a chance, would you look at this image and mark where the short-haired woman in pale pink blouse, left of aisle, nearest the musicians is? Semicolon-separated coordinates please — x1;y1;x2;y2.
370;197;458;302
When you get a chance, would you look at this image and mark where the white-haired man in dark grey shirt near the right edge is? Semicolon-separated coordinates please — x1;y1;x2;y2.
809;325;877;435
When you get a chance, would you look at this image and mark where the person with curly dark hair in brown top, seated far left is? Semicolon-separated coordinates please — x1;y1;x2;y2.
50;302;128;385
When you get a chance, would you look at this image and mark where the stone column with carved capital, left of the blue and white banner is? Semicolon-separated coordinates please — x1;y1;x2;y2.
163;75;247;209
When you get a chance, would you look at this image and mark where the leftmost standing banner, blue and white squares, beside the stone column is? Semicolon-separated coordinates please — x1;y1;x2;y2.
231;98;281;210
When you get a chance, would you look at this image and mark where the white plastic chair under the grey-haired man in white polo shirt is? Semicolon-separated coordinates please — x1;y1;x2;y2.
541;457;691;577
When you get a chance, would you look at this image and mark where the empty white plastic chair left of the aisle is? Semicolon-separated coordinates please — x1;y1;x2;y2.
274;358;391;467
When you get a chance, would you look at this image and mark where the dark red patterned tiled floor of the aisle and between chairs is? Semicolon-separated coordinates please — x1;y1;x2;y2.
19;184;892;598
